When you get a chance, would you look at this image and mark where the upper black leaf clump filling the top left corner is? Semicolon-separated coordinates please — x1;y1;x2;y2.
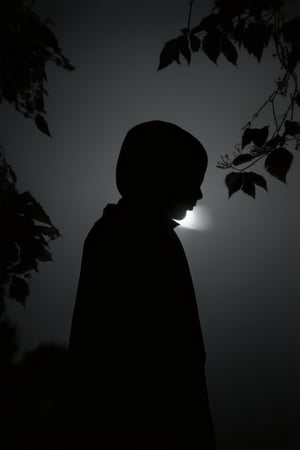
0;0;74;136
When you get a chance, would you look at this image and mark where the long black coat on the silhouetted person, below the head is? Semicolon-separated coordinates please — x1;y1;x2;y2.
69;200;215;450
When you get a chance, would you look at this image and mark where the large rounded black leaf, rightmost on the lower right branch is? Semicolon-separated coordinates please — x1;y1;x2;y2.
265;147;293;183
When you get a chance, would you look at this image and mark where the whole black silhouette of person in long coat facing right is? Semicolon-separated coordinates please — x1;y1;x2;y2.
69;121;215;450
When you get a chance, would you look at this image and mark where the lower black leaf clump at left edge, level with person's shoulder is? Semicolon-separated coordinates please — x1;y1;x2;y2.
0;153;60;305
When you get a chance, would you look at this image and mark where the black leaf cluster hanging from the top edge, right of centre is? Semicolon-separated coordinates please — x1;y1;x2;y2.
158;0;284;70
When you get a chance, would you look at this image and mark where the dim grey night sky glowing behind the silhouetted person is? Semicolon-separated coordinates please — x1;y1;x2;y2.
0;0;300;450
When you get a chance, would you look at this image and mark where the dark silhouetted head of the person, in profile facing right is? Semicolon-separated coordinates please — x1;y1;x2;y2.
116;120;207;219
